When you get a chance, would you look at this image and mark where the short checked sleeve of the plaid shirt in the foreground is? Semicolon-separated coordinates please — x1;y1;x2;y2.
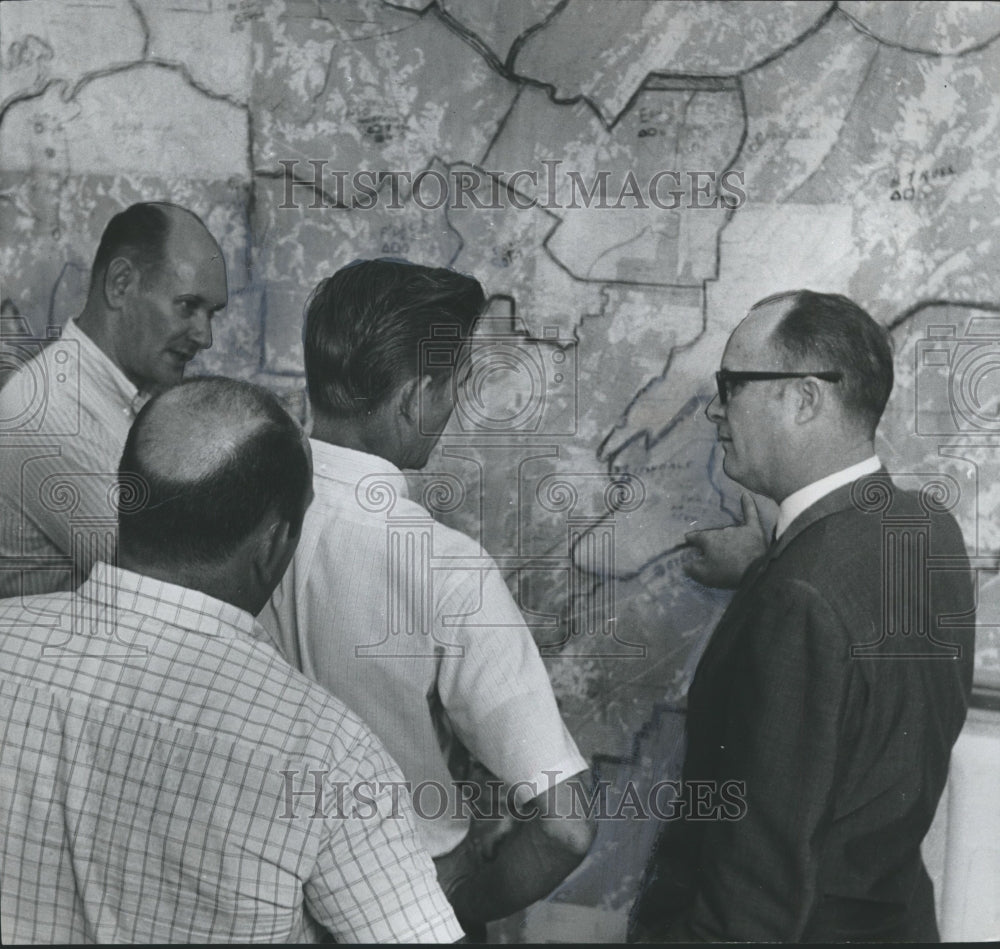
303;724;464;943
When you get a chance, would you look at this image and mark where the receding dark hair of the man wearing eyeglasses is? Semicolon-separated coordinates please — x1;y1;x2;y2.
756;290;893;435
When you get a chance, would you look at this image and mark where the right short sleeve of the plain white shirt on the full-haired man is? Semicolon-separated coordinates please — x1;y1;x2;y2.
435;549;587;804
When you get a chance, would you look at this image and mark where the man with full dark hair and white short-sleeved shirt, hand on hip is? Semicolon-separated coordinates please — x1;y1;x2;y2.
261;259;594;930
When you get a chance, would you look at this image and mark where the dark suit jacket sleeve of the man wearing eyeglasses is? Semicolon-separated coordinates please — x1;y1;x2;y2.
684;581;851;941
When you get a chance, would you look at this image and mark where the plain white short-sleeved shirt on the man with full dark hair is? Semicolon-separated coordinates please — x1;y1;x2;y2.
260;439;587;857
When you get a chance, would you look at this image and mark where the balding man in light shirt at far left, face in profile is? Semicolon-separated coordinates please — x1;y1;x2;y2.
0;202;228;597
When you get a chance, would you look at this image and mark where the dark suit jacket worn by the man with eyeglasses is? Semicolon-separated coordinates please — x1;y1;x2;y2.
633;473;974;941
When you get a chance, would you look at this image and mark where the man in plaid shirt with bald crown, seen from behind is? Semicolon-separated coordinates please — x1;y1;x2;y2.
0;379;462;944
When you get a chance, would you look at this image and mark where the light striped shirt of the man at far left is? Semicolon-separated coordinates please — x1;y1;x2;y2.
0;320;148;597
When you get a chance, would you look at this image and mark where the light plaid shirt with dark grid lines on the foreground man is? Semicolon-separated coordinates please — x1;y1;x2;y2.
0;564;462;943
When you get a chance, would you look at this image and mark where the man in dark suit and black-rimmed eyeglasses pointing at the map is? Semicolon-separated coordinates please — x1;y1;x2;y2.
630;290;975;942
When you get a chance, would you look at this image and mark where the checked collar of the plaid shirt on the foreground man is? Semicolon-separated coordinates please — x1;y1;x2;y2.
78;561;262;639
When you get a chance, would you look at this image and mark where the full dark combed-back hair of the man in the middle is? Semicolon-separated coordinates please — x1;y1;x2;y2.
303;258;486;418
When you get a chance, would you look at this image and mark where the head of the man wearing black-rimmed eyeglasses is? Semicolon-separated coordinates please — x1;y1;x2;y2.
706;290;892;502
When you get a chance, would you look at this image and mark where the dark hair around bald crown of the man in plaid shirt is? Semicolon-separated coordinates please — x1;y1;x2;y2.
118;378;311;565
